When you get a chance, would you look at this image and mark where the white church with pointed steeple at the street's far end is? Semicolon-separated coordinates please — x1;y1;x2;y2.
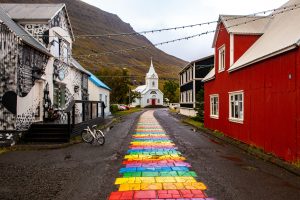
131;59;164;108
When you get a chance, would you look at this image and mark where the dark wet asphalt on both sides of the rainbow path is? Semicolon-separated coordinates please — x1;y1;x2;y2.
0;109;300;200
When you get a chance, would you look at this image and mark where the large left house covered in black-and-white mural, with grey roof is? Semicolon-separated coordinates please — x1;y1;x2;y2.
0;4;105;145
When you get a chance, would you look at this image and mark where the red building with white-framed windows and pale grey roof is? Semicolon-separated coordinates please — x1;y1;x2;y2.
203;0;300;161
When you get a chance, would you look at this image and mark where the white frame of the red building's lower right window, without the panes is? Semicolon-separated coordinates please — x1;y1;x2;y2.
228;90;245;124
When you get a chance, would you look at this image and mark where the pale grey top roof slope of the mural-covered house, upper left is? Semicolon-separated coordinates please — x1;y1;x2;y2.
1;3;65;20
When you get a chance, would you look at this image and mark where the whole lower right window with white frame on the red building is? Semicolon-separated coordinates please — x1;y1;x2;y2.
229;92;244;123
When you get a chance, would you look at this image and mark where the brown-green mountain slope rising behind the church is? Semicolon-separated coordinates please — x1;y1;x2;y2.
0;0;186;82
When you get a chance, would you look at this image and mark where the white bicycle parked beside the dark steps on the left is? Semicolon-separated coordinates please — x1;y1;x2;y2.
81;125;105;145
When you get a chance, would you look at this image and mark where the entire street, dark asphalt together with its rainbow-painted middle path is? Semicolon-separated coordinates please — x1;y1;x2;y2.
0;109;300;200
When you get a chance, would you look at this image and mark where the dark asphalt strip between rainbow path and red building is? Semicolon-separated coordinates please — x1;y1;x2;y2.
155;110;300;200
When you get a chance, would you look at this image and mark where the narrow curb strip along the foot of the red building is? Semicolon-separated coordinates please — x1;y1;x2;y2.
171;111;300;176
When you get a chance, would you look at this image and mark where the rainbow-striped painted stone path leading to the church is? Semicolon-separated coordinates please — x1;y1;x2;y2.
109;111;213;200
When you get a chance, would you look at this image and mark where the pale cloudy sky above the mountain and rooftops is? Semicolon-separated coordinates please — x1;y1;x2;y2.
83;0;287;61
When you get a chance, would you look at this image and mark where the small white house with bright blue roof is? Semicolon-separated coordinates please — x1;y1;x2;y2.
88;73;111;116
